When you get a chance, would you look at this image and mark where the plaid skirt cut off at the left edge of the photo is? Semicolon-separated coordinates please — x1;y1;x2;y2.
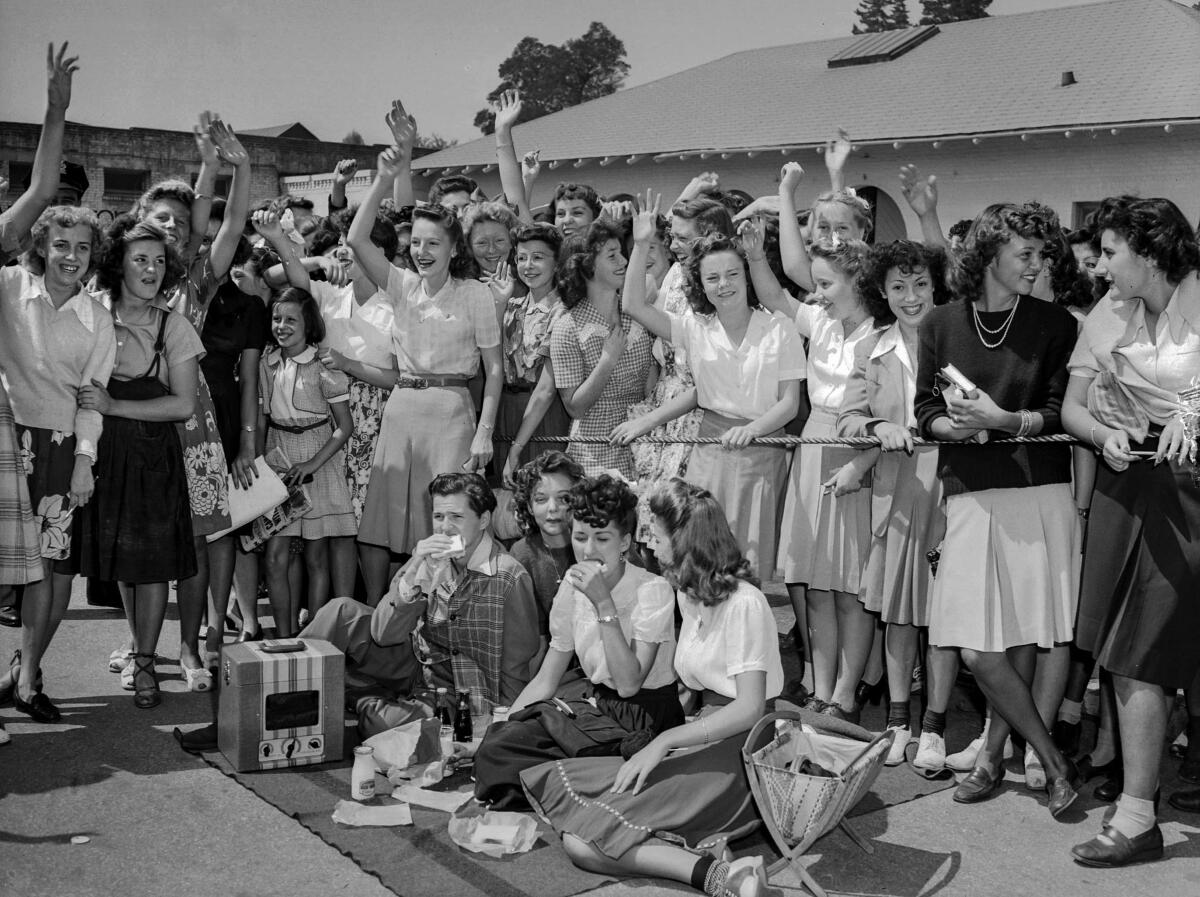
0;383;42;585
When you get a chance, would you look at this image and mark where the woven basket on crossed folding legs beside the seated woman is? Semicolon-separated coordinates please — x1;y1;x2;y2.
742;711;895;897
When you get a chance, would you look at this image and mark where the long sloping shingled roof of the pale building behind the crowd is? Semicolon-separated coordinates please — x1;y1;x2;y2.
415;0;1200;168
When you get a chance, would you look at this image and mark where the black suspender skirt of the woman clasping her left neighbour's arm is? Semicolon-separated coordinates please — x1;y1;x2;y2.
74;378;196;583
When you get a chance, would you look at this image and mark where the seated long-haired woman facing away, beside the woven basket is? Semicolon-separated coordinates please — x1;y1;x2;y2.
521;478;784;897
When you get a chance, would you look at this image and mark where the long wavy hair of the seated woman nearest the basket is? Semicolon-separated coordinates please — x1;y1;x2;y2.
650;477;758;606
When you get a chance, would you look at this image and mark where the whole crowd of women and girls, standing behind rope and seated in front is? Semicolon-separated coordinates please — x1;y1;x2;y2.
0;61;1200;893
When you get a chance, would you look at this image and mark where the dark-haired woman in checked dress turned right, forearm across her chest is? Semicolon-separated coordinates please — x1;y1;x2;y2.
550;221;650;480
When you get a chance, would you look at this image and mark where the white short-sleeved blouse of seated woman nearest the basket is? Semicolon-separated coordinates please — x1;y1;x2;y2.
676;582;784;698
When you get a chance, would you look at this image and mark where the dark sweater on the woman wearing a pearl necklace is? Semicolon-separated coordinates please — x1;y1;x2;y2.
916;296;1076;496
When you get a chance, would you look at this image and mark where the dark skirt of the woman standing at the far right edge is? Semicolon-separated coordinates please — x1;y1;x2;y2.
1076;445;1200;688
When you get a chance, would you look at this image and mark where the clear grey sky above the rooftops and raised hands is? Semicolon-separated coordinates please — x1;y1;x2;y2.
0;0;1108;143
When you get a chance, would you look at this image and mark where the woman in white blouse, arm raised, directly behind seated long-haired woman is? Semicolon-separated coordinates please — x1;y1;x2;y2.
624;197;805;579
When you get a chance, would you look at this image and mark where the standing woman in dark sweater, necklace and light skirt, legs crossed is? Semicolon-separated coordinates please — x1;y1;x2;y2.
916;203;1080;817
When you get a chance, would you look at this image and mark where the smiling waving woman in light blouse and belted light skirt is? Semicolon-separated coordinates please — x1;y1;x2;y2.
347;142;504;602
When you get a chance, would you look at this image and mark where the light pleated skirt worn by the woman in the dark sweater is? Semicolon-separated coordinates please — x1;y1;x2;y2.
929;483;1081;651
